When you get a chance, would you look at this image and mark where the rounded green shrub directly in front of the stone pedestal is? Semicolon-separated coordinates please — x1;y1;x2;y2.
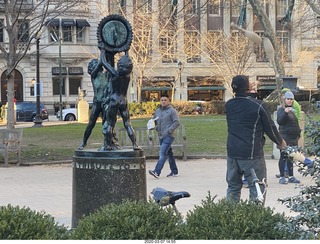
71;200;182;240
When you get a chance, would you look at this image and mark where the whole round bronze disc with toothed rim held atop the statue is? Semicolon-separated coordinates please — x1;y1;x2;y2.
97;14;133;53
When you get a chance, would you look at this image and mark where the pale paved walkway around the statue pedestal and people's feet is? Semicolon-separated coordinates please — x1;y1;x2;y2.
0;159;312;227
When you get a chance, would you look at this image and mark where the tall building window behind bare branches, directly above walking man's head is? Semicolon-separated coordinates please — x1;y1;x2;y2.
159;30;177;63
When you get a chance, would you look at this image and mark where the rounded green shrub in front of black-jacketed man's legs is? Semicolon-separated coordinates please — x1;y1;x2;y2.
184;193;296;240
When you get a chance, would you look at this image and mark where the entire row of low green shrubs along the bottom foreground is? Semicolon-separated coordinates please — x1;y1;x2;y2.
0;196;299;240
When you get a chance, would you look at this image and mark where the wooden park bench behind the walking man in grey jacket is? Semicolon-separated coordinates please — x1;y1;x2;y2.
116;124;187;161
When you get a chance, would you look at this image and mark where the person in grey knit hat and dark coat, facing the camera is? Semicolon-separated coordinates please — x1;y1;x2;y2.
277;91;301;184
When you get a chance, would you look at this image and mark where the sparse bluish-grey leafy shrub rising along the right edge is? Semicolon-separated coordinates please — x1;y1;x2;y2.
278;117;320;240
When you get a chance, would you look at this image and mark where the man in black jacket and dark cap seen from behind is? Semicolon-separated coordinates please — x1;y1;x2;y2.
225;75;286;202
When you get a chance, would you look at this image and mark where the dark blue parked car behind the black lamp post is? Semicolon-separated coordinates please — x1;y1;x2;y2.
16;102;48;122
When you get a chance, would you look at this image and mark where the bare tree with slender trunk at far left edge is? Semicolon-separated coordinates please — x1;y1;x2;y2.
0;0;80;129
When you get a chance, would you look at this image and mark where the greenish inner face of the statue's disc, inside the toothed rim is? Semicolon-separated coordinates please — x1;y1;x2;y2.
102;20;128;47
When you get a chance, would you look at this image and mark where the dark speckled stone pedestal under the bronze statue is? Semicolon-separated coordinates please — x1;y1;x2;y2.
72;149;147;228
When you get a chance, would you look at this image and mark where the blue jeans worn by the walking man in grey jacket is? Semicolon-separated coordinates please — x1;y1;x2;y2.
154;136;178;175
